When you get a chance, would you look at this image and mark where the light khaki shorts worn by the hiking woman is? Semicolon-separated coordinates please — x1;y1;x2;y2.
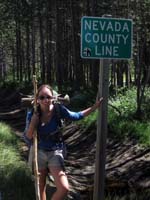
38;149;64;170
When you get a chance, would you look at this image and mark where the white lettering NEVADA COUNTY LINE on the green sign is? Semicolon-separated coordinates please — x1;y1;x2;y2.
84;20;129;56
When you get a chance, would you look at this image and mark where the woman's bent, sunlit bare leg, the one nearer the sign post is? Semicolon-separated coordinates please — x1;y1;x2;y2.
50;167;69;200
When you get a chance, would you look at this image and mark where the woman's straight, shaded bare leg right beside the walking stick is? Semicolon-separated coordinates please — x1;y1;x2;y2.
39;169;47;200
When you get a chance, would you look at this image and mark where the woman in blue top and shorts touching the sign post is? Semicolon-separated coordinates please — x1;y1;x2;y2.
26;85;102;200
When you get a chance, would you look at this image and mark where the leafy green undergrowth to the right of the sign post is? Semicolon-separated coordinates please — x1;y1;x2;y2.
108;88;150;146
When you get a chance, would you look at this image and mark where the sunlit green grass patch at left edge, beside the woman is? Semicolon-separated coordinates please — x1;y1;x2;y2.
0;122;34;200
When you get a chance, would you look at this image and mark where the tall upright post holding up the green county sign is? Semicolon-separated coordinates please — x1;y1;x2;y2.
93;59;109;200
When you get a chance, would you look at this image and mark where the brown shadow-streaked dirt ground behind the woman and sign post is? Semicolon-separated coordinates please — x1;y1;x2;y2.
0;91;150;200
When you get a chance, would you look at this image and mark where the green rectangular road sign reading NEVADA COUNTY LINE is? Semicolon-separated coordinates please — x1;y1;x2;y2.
81;16;133;59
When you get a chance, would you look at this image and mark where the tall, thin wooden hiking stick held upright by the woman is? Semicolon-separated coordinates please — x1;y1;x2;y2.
33;75;41;200
